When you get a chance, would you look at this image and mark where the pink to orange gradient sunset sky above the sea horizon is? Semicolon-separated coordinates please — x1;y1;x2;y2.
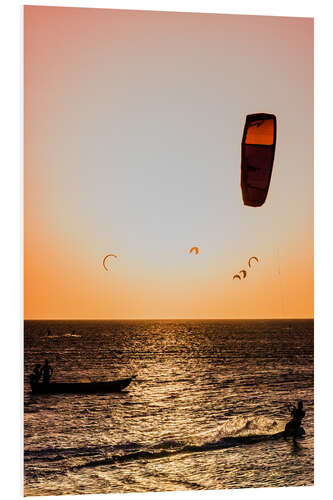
24;6;313;319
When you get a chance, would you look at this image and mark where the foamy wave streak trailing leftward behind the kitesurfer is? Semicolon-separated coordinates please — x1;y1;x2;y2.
25;417;304;472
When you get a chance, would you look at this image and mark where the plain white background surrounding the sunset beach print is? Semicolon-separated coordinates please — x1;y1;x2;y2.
0;0;333;500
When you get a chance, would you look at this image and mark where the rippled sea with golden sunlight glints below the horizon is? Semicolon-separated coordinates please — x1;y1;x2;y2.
24;320;314;495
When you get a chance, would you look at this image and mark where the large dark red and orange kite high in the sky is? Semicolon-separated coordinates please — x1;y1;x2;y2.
241;113;276;207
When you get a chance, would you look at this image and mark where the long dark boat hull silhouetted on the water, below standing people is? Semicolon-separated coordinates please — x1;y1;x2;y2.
30;377;134;394
